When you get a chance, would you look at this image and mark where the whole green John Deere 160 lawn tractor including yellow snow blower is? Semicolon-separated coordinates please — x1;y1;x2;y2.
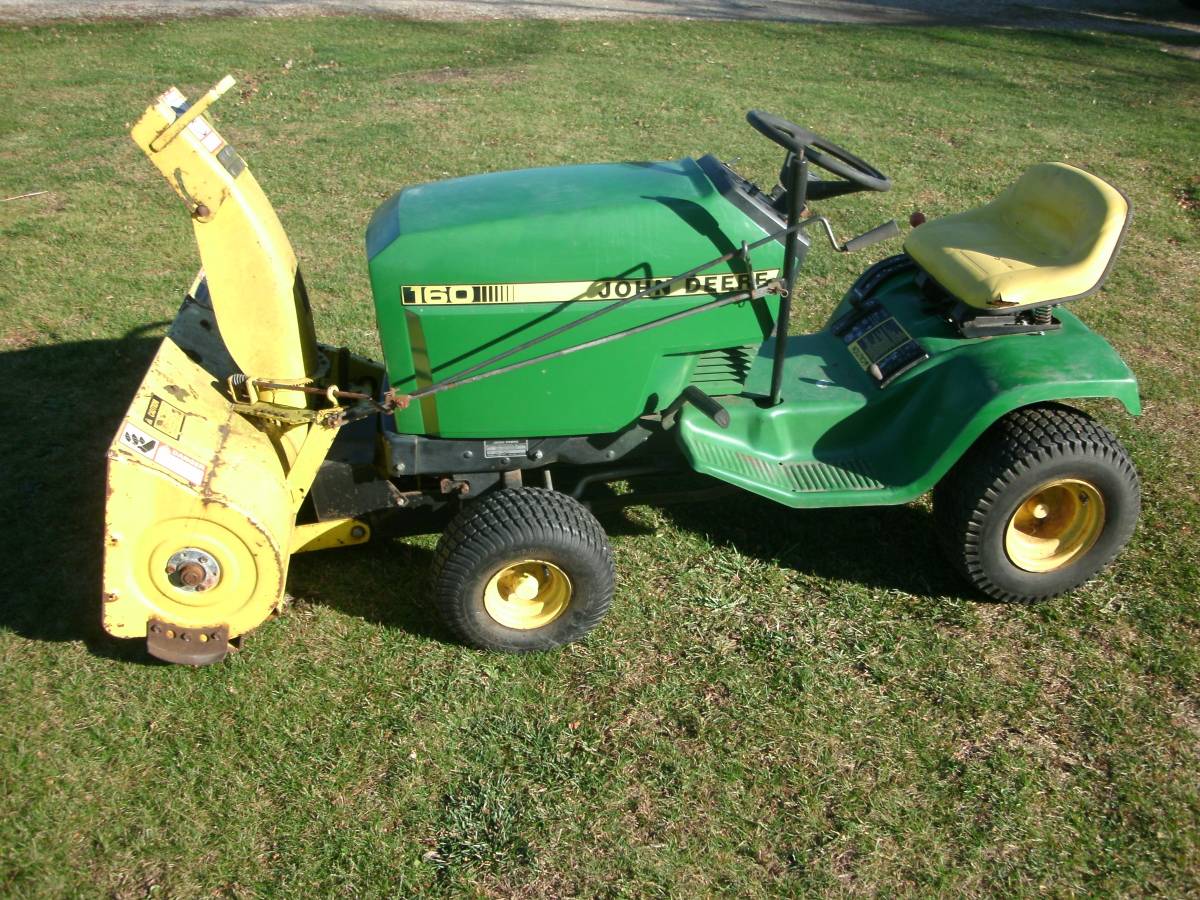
103;78;1140;665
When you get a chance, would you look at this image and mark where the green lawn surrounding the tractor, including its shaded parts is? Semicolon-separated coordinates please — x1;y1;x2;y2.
0;18;1200;898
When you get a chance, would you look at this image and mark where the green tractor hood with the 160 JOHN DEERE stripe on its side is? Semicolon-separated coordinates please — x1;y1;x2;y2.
366;157;782;438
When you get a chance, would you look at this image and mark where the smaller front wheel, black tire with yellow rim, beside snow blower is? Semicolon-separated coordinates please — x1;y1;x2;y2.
432;487;614;653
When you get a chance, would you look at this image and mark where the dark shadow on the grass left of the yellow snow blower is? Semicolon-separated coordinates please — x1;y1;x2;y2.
0;323;166;661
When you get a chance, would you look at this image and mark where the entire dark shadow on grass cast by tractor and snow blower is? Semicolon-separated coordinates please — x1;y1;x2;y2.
0;323;965;661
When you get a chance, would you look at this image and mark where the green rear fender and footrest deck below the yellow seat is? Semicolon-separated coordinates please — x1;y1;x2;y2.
678;296;1141;508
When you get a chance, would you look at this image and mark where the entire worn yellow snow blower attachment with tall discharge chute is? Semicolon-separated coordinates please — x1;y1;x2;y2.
103;77;382;665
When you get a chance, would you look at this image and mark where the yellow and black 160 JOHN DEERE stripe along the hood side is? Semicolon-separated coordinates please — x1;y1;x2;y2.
400;269;779;306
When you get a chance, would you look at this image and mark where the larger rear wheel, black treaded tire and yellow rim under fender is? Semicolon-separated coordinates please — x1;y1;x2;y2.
934;404;1141;602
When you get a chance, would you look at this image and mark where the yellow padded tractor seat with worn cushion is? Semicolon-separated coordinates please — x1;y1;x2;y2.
905;162;1129;312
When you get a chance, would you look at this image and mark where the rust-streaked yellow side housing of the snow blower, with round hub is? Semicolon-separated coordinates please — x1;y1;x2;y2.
102;336;294;655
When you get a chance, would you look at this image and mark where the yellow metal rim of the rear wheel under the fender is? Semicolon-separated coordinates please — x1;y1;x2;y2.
1004;478;1104;572
